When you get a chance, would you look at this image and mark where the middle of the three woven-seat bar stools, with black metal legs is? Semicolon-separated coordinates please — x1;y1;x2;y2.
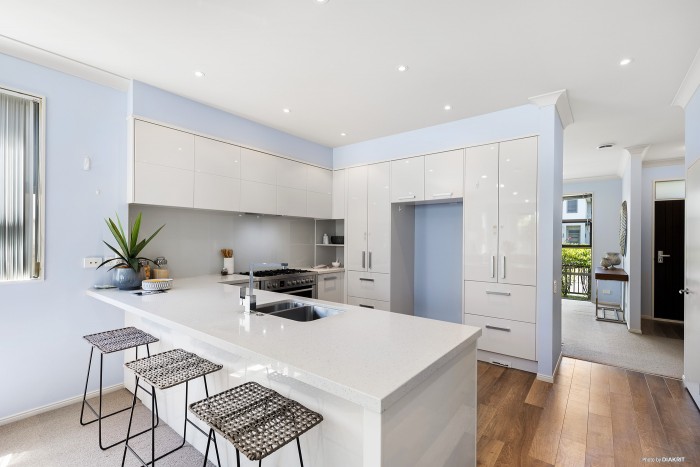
122;349;223;467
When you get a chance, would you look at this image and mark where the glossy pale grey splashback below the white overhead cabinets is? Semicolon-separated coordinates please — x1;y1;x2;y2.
129;205;314;278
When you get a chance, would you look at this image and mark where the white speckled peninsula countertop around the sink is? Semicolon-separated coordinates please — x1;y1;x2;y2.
87;275;481;412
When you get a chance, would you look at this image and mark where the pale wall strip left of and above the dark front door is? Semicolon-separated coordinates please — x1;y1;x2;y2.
641;163;685;317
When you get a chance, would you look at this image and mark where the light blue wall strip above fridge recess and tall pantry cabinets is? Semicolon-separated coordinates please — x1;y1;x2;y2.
333;105;539;169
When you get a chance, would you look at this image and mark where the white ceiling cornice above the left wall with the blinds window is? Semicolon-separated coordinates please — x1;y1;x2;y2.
0;35;129;91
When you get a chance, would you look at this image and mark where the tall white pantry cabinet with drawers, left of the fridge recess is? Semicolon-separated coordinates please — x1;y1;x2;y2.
345;162;391;310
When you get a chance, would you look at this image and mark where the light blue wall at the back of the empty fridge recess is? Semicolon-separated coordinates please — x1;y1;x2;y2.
414;203;463;323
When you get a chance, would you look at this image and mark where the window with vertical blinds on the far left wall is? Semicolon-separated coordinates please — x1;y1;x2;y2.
0;88;44;281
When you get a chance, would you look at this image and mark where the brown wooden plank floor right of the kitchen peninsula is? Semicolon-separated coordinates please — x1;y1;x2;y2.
477;358;700;466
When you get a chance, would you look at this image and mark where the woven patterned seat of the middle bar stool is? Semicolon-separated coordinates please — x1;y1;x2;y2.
125;349;223;389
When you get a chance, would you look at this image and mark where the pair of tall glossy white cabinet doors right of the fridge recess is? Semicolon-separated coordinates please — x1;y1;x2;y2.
464;137;537;285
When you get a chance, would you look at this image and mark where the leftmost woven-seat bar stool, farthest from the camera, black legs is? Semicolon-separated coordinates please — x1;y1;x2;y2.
80;327;158;450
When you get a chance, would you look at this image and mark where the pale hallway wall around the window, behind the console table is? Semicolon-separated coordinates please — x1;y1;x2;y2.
564;178;622;303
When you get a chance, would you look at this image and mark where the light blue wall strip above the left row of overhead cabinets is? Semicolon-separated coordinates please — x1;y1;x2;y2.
129;81;333;168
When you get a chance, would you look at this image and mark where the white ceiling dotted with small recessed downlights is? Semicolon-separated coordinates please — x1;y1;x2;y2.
0;0;700;178
